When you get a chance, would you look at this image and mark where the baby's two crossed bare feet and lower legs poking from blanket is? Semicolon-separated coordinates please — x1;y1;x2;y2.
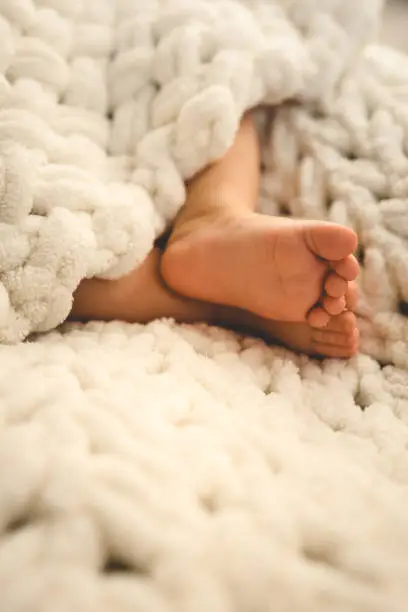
71;116;358;358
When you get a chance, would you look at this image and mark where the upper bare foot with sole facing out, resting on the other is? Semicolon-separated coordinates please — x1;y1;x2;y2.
161;213;358;327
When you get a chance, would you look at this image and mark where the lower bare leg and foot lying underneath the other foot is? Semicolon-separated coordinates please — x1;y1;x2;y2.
70;249;358;358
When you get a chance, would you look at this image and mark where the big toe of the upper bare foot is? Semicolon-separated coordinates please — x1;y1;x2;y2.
305;222;358;261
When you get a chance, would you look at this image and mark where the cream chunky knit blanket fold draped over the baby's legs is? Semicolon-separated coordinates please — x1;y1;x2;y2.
0;0;381;342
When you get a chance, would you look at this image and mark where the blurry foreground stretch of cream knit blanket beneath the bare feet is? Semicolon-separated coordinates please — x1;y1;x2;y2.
0;322;408;612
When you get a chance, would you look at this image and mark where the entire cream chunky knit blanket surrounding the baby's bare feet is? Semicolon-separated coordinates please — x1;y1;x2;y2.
0;0;408;612
